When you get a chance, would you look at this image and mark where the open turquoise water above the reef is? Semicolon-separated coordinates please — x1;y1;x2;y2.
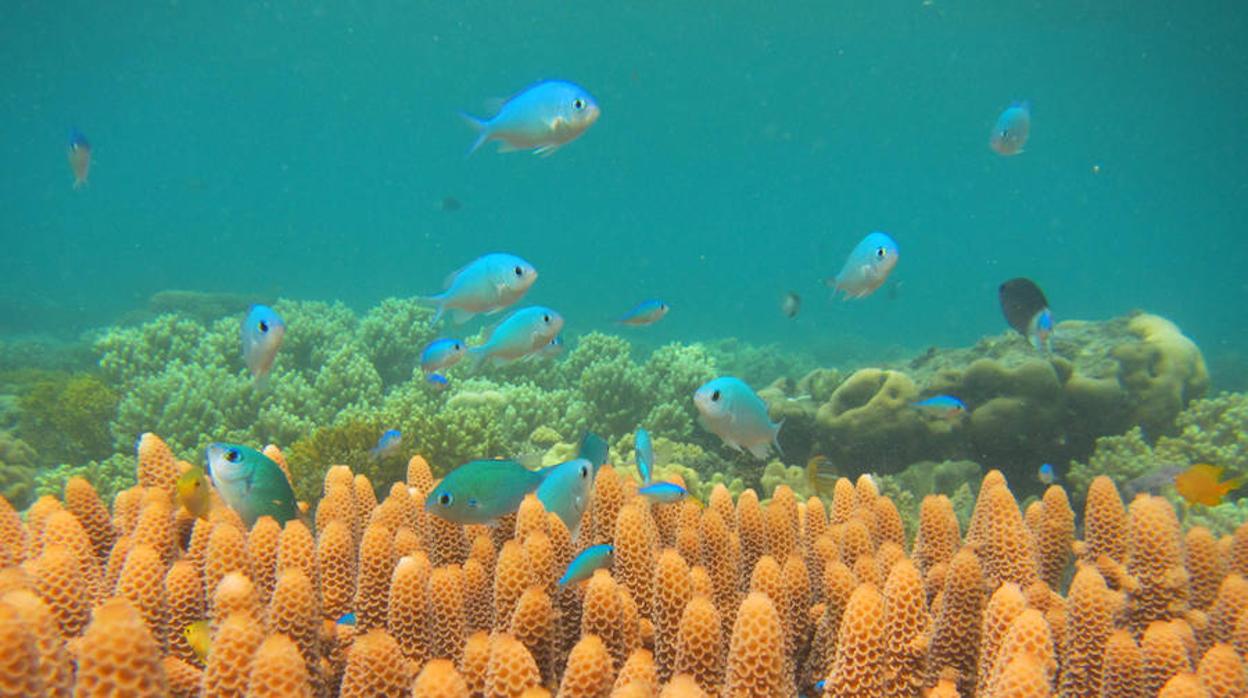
0;0;1248;374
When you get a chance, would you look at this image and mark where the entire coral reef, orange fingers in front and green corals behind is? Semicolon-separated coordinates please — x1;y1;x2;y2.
0;292;1248;698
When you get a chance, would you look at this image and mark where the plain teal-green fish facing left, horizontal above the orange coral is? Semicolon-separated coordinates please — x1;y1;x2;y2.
424;461;544;523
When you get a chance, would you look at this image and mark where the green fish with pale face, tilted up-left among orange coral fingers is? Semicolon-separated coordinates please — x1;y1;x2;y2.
207;443;298;528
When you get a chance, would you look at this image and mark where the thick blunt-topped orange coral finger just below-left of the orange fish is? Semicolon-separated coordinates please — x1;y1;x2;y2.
1127;496;1188;636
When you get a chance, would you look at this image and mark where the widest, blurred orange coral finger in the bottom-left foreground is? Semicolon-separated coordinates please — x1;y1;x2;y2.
77;598;168;698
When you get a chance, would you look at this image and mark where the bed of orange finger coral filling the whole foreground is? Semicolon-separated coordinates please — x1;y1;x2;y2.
0;435;1248;698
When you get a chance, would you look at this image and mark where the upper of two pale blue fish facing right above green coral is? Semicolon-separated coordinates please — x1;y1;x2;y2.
418;252;538;325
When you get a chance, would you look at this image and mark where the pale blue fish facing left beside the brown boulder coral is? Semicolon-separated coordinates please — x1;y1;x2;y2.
694;376;784;460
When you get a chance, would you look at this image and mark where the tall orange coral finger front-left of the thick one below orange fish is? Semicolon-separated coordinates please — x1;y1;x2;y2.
1060;564;1122;698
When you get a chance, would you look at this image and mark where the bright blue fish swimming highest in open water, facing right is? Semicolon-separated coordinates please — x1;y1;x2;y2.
462;80;599;156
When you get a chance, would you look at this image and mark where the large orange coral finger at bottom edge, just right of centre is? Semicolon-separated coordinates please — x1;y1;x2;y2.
725;592;785;697
